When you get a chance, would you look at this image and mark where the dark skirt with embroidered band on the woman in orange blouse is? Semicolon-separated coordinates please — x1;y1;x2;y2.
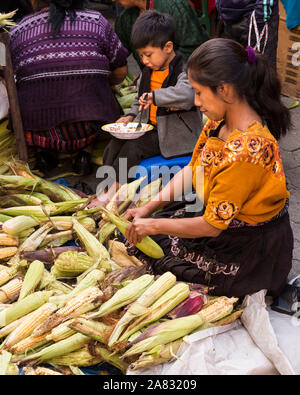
127;202;293;297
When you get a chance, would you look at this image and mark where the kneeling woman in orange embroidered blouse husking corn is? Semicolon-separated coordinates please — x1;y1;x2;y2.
126;39;293;297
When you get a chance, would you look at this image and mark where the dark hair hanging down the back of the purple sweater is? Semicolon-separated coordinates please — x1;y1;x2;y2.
40;0;87;34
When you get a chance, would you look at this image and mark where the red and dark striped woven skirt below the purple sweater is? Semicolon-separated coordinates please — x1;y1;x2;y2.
25;121;101;153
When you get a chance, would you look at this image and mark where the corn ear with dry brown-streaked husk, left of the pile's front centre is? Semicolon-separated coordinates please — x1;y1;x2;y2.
33;287;103;336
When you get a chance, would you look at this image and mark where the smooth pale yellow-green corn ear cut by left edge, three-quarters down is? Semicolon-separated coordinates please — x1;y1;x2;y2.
0;291;53;328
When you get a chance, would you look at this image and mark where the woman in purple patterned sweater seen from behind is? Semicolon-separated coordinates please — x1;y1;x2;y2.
11;0;128;175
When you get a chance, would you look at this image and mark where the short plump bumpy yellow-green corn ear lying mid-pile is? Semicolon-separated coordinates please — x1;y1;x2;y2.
51;251;94;278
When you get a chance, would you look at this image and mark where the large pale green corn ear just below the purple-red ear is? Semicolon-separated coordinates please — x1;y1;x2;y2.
123;314;204;358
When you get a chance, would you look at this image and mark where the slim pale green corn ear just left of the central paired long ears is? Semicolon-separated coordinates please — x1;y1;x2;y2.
88;274;154;318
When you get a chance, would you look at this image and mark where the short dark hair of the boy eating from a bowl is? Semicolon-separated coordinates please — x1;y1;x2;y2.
131;11;175;49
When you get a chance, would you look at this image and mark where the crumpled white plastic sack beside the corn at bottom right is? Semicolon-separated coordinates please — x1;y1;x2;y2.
127;291;295;375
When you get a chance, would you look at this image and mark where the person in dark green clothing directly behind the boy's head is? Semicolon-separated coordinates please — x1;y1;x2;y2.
113;0;209;66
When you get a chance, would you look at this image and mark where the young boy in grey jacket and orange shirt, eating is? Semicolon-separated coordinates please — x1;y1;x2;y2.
92;11;203;206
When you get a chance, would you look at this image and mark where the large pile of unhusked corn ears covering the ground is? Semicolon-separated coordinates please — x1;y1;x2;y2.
0;162;242;375
